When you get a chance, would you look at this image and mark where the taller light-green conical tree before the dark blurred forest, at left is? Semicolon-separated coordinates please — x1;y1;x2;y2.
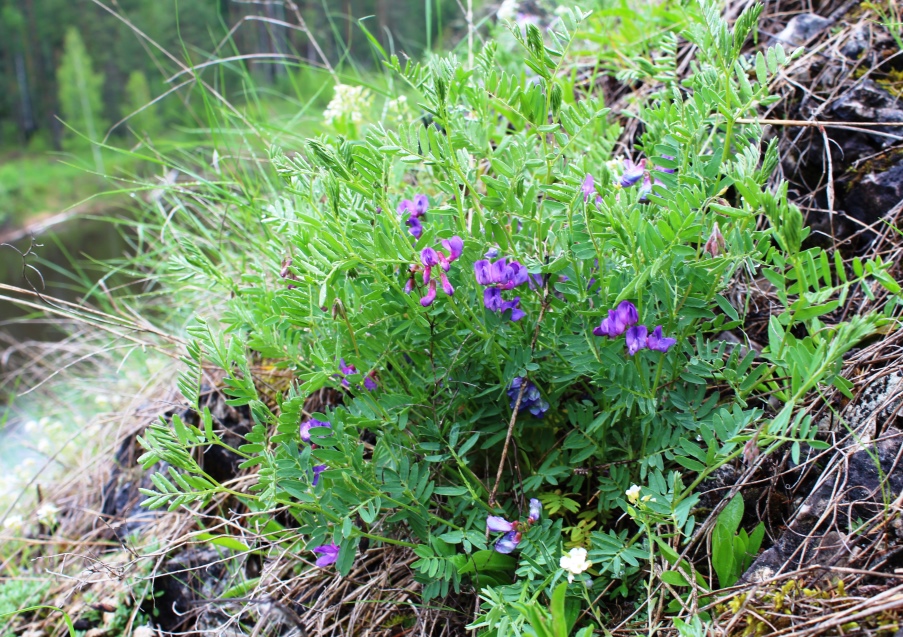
57;27;106;172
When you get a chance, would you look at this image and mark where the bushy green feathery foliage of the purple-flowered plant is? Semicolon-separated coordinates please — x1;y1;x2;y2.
132;3;899;636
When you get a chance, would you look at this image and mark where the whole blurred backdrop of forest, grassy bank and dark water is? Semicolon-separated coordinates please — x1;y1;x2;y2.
0;0;494;348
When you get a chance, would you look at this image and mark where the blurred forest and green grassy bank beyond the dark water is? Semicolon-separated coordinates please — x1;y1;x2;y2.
0;0;479;228
